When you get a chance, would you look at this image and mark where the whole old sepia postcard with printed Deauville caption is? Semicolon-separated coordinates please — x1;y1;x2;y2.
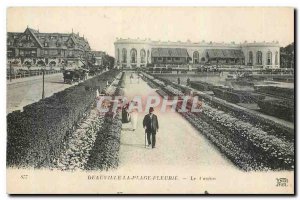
3;7;295;195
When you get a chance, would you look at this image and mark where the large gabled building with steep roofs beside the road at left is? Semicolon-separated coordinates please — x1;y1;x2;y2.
7;27;91;68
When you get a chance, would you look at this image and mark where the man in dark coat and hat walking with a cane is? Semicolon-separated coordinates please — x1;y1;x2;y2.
143;107;158;148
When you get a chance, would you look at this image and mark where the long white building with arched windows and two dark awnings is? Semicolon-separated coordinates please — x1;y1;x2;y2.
114;38;280;68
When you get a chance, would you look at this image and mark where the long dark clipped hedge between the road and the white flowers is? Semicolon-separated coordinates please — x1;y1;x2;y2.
7;71;118;168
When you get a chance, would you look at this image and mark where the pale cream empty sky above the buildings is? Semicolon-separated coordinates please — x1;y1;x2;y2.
7;7;294;56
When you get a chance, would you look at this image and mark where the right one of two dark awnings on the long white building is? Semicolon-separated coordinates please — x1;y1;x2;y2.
206;49;245;58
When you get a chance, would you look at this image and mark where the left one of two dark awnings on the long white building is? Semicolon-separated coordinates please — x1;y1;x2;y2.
151;48;189;57
